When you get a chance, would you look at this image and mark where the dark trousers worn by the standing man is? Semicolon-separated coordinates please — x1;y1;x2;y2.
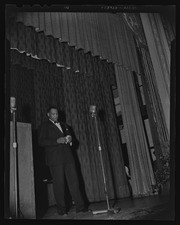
50;163;84;209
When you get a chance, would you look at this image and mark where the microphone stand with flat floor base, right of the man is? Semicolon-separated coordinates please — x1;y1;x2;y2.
91;111;120;214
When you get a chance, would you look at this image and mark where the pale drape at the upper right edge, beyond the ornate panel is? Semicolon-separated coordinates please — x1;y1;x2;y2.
140;13;170;133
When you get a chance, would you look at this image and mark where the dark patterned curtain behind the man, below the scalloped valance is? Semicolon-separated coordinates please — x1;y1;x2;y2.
11;50;129;201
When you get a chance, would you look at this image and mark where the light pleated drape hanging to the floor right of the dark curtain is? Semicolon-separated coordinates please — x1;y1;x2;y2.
115;65;155;196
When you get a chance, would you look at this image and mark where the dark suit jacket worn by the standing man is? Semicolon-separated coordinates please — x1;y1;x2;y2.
38;120;74;166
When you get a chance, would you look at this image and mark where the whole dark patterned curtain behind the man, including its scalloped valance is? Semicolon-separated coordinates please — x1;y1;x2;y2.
6;20;129;201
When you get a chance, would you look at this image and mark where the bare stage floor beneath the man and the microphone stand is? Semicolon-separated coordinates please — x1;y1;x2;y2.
41;195;174;220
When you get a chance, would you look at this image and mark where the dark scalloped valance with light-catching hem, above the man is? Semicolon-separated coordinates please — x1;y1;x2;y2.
6;18;115;84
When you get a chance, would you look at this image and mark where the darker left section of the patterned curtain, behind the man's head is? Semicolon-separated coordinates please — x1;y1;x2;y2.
10;50;64;129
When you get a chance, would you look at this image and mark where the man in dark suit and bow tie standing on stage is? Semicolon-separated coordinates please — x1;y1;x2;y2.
39;106;88;215
